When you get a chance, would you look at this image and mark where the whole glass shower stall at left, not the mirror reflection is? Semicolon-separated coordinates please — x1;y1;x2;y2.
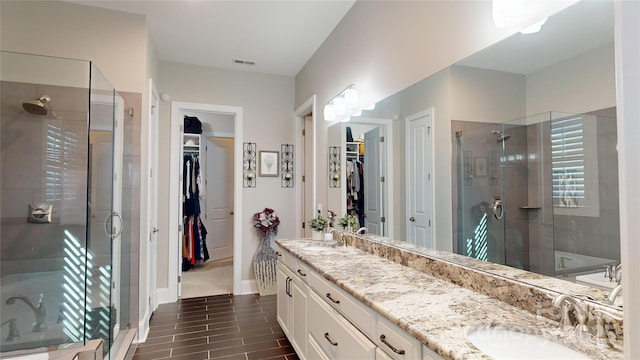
0;52;130;358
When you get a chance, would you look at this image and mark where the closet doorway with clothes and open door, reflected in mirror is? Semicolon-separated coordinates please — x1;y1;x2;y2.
328;118;393;236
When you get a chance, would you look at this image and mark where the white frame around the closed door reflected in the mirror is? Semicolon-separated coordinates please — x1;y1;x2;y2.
404;107;436;249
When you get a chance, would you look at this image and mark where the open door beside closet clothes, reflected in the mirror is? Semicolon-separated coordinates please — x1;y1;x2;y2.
356;127;385;236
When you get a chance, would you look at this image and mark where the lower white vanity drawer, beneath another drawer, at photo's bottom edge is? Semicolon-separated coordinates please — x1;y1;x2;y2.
308;292;376;360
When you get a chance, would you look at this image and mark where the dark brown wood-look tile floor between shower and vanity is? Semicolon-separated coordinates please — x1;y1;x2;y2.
133;294;298;360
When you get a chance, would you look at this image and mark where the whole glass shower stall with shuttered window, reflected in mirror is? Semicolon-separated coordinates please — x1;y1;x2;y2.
454;109;620;277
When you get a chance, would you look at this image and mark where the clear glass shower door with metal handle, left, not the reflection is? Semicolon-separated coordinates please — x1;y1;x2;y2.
85;64;122;358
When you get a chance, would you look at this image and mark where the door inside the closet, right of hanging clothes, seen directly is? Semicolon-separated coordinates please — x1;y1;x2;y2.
204;137;234;260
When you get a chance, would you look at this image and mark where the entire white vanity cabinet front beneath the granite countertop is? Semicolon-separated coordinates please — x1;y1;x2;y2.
277;246;442;360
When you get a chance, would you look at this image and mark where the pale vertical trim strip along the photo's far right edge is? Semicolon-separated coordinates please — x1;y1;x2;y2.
614;1;640;359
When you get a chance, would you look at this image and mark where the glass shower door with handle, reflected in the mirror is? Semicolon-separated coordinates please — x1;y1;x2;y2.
456;124;508;264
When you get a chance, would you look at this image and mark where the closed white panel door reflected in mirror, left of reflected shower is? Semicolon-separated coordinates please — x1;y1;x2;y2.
406;109;434;248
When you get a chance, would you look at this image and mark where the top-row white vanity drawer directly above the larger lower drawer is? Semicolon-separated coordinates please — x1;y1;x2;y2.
309;271;376;339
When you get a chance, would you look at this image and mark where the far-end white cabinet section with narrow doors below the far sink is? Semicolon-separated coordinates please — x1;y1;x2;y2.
276;253;309;359
